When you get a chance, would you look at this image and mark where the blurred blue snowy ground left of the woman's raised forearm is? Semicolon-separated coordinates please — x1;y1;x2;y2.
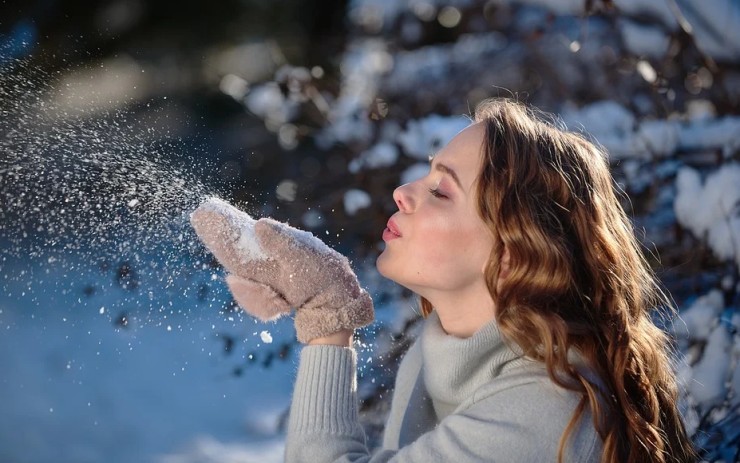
0;250;296;463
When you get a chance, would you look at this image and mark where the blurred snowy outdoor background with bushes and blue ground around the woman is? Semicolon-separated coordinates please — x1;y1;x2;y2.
0;0;740;463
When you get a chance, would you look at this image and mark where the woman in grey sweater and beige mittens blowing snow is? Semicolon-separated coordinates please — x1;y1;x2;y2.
193;100;694;463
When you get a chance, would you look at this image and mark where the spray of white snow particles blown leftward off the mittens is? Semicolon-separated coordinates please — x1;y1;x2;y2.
0;53;251;322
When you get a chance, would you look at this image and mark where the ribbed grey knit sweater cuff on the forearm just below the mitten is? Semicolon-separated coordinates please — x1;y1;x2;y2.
289;345;359;434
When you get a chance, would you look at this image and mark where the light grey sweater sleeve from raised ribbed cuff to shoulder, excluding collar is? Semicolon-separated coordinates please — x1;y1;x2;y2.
286;346;599;463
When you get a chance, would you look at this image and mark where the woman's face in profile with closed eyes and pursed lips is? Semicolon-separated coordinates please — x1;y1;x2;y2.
377;124;493;298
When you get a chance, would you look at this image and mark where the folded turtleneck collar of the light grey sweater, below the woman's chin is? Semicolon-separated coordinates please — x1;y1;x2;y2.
421;311;522;419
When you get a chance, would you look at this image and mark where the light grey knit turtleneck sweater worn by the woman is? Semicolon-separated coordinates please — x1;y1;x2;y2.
286;313;602;463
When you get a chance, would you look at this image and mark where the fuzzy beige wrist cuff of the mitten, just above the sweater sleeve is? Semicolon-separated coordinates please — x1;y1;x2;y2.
295;290;375;344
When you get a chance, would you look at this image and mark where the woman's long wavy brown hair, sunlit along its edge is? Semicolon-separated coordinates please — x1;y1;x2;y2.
422;99;695;463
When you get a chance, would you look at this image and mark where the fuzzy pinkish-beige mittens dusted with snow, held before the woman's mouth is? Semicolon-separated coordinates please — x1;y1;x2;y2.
192;198;374;343
